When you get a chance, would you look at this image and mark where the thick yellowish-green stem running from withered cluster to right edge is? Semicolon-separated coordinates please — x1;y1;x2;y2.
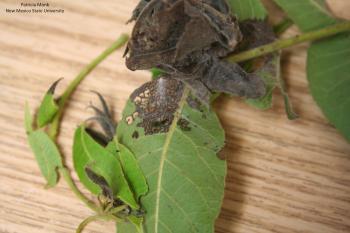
225;22;350;62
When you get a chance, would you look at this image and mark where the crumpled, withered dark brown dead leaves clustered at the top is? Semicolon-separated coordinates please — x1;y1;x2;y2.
126;0;265;103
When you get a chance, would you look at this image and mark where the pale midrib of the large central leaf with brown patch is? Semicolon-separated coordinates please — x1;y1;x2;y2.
154;86;190;233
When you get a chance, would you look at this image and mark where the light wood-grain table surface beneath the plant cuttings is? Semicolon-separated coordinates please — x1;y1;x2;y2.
0;0;350;233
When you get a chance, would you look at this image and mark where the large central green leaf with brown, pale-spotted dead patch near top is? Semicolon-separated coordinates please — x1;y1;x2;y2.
117;77;226;233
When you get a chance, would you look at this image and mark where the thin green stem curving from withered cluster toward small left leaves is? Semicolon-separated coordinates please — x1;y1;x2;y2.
48;34;129;140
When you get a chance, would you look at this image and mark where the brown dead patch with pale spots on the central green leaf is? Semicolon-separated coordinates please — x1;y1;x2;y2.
129;77;184;135
